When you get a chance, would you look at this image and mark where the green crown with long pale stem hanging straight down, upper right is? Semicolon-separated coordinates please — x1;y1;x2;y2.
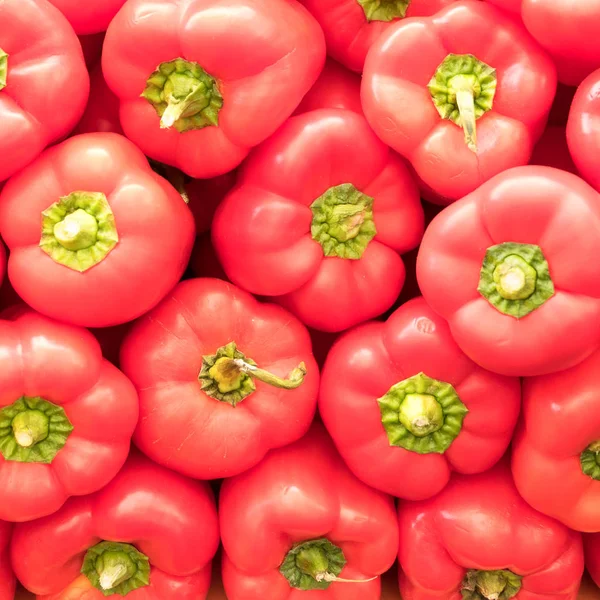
427;54;497;152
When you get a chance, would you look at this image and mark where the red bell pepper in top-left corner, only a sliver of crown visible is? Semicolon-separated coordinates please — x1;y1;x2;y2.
0;0;89;182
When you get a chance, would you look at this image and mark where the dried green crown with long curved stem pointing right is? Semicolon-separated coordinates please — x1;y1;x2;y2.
198;342;306;407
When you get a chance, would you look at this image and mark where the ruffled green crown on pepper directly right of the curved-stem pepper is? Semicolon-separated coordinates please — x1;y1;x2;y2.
377;373;469;454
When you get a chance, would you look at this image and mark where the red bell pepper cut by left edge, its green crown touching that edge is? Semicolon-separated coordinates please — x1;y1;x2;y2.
0;308;138;521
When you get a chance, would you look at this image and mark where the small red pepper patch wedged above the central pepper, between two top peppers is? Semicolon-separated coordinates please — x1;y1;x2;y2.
294;58;362;115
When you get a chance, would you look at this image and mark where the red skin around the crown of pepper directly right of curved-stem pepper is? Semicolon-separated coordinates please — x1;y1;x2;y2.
319;298;521;500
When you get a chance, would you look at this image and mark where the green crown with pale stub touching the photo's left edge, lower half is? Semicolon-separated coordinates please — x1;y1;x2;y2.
0;396;73;464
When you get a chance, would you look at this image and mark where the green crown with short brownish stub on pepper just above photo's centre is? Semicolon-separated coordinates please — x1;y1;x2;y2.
310;183;377;260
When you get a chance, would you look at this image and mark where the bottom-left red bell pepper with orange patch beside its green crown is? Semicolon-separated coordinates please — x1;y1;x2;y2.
11;453;219;600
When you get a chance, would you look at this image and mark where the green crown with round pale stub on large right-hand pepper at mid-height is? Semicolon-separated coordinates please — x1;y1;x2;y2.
477;242;554;319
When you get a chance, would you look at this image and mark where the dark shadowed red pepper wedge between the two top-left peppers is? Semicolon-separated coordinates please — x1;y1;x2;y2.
74;64;123;134
